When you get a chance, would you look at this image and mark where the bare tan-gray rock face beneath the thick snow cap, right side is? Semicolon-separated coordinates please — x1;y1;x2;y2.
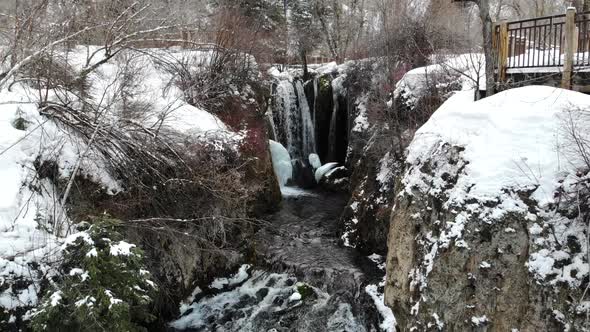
385;145;588;331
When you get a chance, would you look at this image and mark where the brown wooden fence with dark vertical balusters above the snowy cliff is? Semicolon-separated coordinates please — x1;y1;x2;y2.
492;8;590;89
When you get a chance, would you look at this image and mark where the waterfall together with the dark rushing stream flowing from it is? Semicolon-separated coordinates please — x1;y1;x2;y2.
171;73;388;332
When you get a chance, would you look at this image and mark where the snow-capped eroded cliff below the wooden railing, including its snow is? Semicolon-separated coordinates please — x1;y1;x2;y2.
385;91;589;331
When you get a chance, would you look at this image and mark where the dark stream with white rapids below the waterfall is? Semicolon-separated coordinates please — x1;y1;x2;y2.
170;190;394;332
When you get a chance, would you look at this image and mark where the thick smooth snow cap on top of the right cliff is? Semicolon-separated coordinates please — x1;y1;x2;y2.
404;86;590;213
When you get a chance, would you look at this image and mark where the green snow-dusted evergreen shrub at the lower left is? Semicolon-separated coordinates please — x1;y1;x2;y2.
32;217;156;331
